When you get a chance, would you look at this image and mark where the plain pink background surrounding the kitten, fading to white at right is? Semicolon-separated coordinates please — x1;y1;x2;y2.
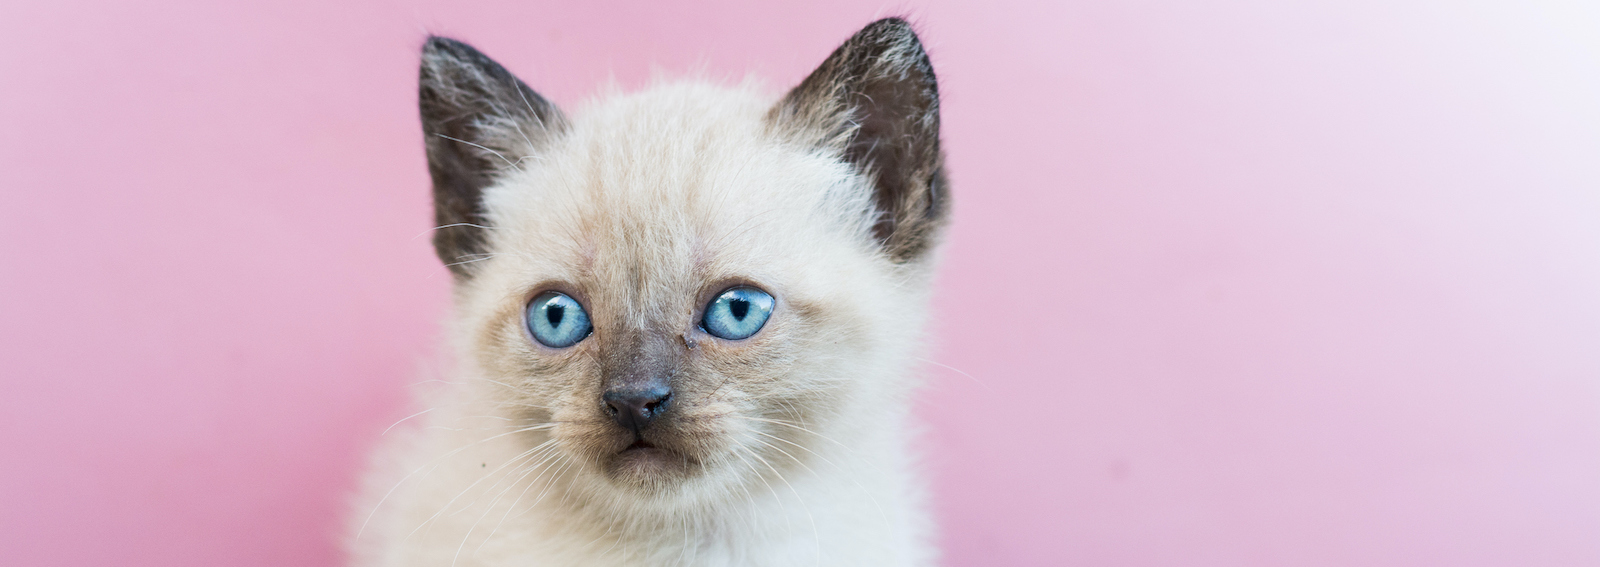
0;0;1600;565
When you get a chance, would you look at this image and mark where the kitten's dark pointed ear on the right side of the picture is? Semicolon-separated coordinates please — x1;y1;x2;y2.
768;18;949;263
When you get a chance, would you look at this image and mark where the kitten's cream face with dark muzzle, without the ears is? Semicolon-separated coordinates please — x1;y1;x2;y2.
464;86;912;493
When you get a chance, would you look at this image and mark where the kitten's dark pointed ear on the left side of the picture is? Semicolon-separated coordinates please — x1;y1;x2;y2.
418;37;566;280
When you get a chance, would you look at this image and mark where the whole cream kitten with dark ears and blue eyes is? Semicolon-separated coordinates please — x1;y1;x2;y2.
352;18;947;567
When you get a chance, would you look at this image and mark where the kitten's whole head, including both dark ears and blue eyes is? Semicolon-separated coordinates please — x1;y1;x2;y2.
421;19;947;506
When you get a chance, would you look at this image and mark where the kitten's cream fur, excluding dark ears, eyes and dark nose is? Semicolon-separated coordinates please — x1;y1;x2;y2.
350;19;936;567
